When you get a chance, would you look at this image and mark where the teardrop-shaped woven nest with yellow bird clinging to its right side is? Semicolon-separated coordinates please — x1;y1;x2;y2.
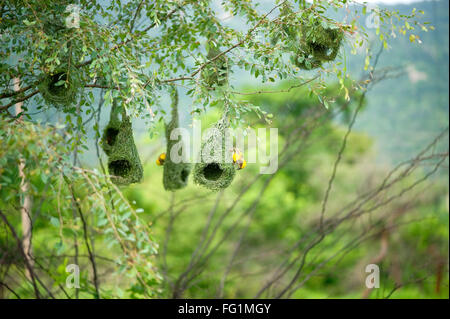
193;112;236;191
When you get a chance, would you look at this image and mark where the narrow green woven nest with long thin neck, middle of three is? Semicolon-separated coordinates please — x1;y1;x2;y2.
163;88;191;191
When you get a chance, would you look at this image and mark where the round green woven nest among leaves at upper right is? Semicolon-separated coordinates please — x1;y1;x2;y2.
294;22;344;70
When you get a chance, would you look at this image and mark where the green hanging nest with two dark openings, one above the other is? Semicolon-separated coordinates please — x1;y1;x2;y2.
101;101;143;185
